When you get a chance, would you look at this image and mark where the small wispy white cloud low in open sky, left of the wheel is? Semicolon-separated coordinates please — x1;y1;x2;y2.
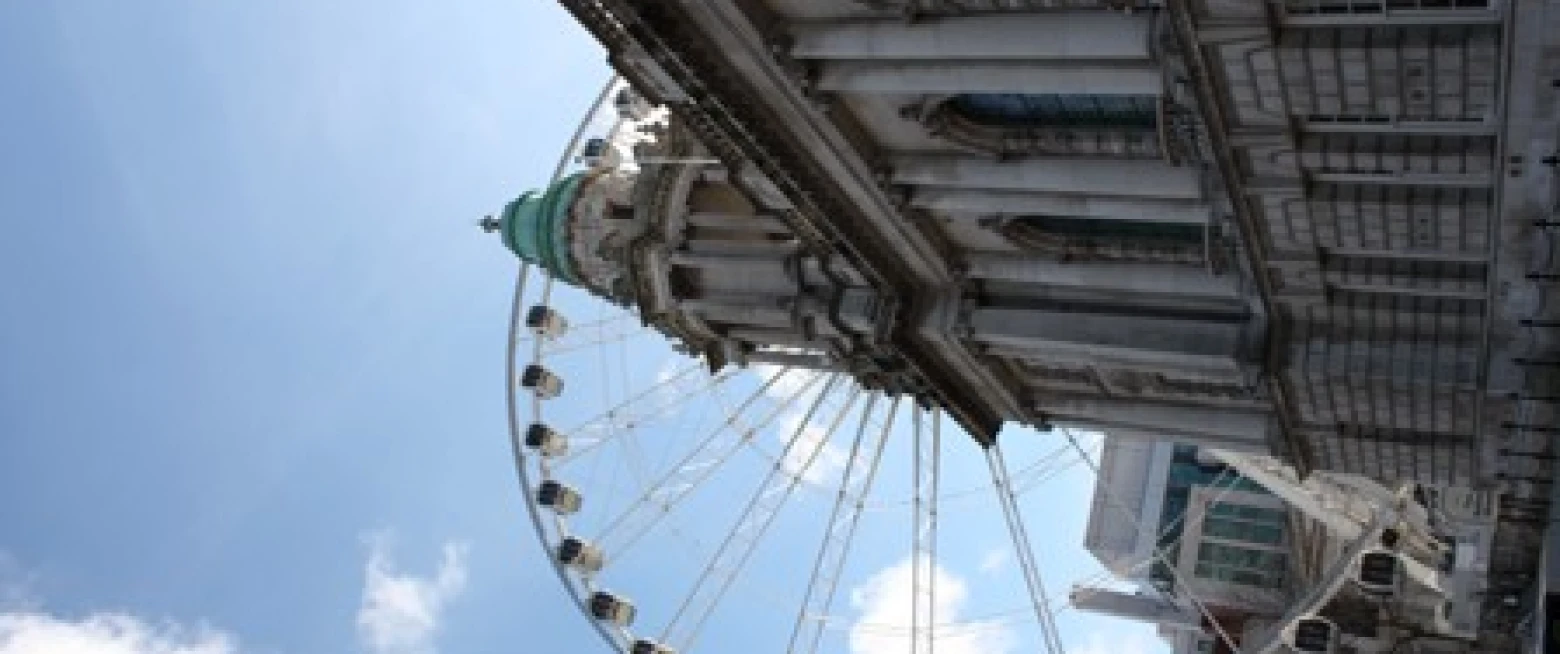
357;535;466;654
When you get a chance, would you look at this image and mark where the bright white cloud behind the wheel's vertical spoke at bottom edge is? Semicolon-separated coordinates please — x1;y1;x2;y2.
850;557;1016;654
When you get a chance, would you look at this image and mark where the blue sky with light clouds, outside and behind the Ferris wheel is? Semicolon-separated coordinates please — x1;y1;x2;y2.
0;0;1154;654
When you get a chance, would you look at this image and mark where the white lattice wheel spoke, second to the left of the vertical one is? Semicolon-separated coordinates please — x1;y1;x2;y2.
661;375;863;651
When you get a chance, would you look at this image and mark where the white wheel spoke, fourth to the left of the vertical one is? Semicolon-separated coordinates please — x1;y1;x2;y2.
552;361;733;467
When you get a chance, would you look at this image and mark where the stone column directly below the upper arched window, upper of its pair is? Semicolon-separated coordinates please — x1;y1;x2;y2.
894;155;1201;200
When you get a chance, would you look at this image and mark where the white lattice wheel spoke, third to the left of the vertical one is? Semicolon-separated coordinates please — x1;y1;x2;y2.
599;371;836;557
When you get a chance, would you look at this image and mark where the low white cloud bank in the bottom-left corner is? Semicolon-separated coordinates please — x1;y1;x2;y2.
0;612;237;654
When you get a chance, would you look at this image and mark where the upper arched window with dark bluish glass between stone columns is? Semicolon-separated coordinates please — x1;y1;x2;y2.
948;94;1159;128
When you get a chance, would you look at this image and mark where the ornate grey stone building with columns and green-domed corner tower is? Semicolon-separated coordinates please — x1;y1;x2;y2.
491;0;1560;649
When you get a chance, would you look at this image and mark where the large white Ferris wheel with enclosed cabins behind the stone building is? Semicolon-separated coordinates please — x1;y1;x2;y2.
492;80;1228;654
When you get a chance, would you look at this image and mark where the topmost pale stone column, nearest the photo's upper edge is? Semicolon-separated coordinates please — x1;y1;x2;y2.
791;9;1151;61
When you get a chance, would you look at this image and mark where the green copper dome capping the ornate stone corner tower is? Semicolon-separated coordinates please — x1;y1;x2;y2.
499;173;585;286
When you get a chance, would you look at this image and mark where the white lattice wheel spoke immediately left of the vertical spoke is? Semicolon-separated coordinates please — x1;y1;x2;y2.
786;395;900;652
